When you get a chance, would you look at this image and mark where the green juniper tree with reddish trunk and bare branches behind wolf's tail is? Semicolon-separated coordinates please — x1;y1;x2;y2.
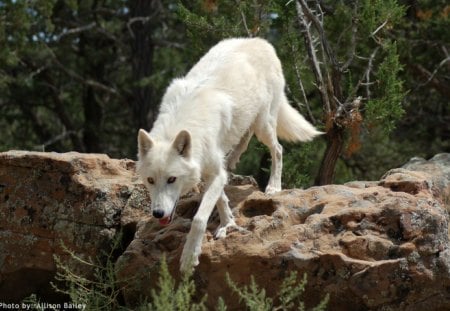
180;0;405;184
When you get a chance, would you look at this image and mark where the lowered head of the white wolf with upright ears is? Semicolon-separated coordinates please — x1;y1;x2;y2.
136;129;200;225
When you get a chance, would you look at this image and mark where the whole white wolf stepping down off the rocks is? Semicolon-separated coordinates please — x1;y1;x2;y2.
137;38;321;271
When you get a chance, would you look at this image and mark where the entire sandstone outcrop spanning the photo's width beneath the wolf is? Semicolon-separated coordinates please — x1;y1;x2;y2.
0;152;450;310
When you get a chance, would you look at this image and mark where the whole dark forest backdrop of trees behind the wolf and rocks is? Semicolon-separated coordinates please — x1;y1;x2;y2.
0;0;450;187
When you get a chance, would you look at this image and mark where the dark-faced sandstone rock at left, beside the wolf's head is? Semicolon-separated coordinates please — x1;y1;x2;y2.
0;151;148;302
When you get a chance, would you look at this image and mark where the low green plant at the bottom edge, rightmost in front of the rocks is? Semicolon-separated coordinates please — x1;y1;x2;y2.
226;271;329;311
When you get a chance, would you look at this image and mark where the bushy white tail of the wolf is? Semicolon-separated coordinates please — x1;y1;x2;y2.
277;98;323;142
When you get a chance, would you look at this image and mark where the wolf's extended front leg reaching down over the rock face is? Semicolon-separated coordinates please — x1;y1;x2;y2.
180;168;227;272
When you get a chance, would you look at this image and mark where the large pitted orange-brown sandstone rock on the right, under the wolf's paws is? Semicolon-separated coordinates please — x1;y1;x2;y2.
117;154;450;310
